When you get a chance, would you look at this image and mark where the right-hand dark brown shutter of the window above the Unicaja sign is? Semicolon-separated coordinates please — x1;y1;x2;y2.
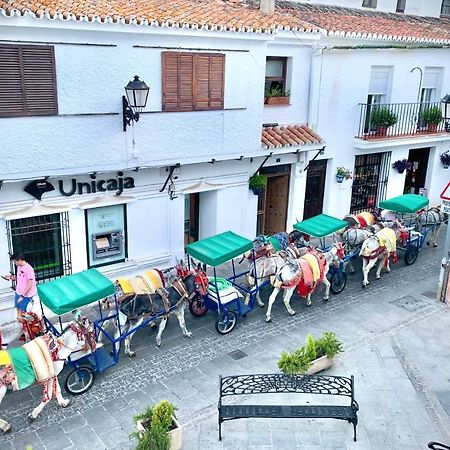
22;46;58;116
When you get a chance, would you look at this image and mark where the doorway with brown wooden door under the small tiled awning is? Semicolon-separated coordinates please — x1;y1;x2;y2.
257;164;291;235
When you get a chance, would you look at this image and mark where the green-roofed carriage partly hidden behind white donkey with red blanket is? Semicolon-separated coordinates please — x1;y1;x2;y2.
294;214;348;294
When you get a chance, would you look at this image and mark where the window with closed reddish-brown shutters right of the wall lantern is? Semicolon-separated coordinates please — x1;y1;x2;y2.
162;52;225;112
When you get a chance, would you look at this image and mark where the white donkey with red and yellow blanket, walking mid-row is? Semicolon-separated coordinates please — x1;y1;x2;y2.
266;242;345;322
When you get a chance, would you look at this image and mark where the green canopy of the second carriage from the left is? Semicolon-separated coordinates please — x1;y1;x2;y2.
186;231;253;266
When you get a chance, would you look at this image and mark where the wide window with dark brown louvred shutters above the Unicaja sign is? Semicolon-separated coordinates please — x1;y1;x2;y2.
0;45;58;117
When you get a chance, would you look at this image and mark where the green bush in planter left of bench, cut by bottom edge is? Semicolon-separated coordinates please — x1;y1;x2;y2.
130;400;176;450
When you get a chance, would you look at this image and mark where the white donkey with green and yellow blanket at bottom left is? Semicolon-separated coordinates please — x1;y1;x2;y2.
0;318;97;433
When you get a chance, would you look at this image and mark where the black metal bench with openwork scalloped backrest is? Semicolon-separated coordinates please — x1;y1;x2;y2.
219;374;359;442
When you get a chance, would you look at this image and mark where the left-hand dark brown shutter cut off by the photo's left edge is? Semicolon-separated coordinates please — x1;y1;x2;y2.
0;46;24;117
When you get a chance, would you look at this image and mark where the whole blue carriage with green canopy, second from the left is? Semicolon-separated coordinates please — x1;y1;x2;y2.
186;231;269;334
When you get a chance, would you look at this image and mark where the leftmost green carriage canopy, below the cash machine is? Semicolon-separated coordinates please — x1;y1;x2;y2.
38;269;115;315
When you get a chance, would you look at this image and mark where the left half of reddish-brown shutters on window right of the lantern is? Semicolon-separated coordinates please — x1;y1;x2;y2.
162;52;193;112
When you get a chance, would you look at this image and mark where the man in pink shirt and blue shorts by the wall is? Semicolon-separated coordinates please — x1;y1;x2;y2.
3;254;37;321
